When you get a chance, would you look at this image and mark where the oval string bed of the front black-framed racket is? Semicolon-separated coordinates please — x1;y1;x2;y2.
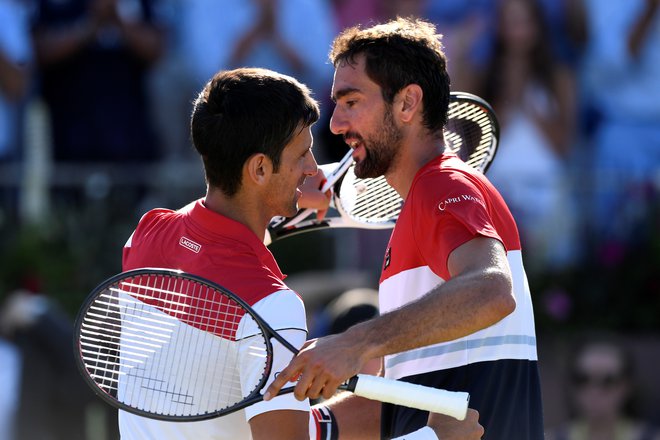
80;276;268;417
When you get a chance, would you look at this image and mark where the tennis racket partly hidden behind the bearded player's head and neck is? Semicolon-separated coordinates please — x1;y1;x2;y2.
264;92;499;245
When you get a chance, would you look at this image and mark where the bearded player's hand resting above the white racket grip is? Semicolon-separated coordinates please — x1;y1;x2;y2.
264;333;368;400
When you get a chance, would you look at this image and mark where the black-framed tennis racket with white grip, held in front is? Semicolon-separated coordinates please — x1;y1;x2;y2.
74;268;469;421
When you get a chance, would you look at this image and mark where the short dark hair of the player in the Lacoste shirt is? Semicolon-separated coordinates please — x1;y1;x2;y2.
190;68;320;197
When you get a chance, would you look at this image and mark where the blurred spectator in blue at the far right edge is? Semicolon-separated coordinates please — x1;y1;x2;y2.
581;0;660;265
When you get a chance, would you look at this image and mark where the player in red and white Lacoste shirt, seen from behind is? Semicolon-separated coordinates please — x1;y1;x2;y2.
119;68;481;440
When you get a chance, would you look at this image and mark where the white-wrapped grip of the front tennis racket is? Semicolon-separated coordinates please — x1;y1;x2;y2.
348;374;470;420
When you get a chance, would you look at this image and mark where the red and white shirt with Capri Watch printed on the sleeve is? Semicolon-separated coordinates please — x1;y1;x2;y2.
379;154;537;379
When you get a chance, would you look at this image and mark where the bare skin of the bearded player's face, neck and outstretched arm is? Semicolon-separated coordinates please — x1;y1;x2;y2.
265;55;515;406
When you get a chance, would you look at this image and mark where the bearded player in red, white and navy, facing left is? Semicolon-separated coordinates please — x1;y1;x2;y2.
268;18;543;440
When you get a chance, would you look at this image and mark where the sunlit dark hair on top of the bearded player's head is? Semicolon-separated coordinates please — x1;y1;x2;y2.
330;17;450;133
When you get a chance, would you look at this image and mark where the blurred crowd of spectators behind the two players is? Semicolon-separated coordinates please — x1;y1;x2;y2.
0;0;660;440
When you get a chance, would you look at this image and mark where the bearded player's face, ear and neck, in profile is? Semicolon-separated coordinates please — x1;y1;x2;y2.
330;55;444;199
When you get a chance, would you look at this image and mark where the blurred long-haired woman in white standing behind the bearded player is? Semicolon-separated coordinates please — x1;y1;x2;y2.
479;0;576;270
